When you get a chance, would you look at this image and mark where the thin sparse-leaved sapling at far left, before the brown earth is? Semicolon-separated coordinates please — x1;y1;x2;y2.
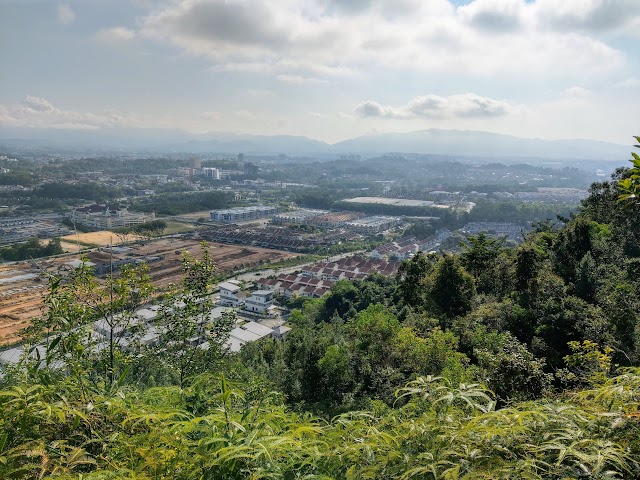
25;261;154;389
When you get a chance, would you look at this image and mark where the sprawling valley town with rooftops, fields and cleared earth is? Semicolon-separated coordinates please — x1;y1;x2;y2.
0;147;599;363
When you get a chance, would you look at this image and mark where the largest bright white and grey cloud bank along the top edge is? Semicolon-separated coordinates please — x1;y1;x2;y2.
135;0;640;80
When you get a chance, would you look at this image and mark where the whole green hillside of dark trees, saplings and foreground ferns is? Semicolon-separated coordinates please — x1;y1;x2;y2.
0;144;640;480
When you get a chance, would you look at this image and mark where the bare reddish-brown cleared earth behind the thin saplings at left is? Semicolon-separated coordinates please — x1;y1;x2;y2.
0;239;295;345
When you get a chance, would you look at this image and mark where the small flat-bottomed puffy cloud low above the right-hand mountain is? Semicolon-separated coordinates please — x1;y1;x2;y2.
355;93;517;120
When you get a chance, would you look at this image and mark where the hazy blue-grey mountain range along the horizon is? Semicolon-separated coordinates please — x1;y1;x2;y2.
0;128;630;162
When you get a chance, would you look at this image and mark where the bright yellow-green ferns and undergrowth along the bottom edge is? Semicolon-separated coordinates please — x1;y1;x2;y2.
0;370;640;479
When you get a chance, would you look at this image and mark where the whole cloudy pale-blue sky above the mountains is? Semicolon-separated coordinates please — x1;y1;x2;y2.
0;0;640;144
